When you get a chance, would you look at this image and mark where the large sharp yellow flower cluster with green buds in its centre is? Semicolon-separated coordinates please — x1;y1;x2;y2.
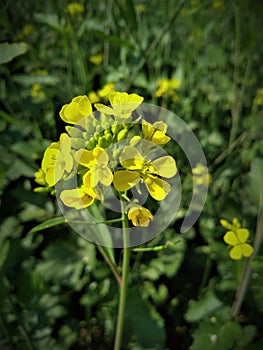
35;92;177;227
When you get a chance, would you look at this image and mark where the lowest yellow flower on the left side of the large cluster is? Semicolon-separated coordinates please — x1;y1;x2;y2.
60;187;95;210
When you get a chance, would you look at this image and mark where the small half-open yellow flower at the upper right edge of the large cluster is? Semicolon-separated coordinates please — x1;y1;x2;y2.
142;120;170;145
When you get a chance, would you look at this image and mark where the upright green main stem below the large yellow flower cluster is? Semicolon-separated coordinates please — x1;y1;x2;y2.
114;200;130;350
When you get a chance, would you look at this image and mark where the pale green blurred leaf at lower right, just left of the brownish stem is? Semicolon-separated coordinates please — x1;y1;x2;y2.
185;290;222;322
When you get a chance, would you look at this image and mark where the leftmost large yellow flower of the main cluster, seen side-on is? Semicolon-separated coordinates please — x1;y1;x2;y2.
35;133;73;186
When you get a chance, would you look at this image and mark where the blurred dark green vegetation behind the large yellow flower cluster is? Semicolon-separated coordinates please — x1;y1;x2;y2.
0;0;263;350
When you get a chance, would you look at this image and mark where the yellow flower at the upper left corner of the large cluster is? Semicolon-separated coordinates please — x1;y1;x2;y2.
59;96;92;124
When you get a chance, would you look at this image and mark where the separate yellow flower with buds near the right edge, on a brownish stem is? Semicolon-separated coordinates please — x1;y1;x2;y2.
220;218;254;260
